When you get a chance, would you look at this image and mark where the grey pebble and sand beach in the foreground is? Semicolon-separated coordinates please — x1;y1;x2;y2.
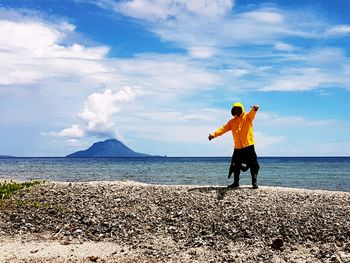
0;181;350;262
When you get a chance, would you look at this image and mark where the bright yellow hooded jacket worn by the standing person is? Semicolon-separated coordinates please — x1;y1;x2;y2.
211;102;256;149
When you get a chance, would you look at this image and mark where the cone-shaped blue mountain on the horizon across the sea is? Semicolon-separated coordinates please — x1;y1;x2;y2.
66;139;154;158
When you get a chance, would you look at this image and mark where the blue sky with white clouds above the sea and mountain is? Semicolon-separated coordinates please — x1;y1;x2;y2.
0;0;350;156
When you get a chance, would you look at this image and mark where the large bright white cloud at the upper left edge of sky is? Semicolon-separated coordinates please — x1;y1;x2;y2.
0;18;109;85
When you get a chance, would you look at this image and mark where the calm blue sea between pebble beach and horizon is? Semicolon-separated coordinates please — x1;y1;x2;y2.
0;157;350;192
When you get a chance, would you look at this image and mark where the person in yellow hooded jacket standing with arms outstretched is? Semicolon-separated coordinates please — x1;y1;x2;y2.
208;102;260;189
